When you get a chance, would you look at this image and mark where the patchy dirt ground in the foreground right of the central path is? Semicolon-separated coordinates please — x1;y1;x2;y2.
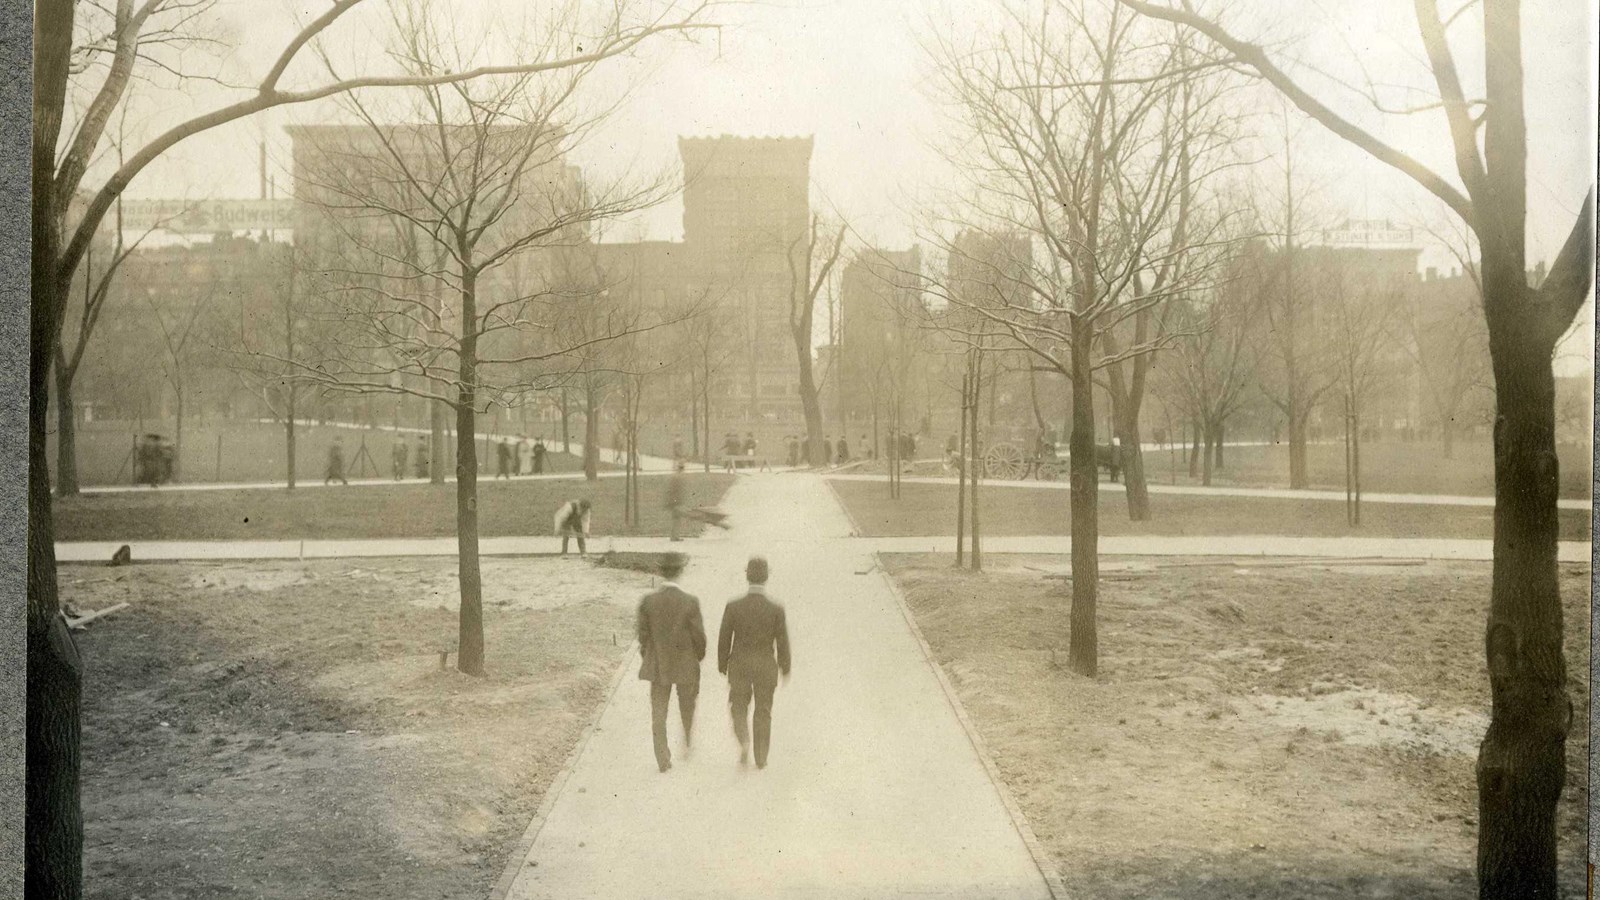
885;554;1589;900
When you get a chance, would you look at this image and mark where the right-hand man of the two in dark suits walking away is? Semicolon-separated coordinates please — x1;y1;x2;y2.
717;556;789;769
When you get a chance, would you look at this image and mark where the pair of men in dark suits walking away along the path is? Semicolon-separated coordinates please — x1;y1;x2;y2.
637;552;790;772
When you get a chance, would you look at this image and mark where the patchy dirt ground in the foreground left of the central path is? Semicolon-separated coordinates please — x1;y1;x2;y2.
61;559;650;900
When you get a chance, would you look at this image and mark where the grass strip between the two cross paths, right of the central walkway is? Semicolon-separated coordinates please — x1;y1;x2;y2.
829;480;1590;541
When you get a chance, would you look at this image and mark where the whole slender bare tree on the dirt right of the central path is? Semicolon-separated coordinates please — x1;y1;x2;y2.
930;0;1214;676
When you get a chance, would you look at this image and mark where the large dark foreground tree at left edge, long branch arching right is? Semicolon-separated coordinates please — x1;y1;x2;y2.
24;0;710;898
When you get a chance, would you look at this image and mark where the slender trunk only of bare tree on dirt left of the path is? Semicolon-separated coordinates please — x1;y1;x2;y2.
454;271;483;676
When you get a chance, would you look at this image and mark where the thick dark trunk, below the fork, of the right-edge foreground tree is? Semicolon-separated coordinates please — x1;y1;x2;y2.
1477;294;1573;900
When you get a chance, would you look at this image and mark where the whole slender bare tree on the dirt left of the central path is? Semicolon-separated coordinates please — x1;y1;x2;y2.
278;16;678;674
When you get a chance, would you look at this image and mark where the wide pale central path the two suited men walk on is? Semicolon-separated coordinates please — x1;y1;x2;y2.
502;476;1050;900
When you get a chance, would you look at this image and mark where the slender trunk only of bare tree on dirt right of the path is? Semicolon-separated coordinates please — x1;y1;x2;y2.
1067;322;1099;677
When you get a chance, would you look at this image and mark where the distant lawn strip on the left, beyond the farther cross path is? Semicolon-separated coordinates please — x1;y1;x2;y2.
50;420;604;487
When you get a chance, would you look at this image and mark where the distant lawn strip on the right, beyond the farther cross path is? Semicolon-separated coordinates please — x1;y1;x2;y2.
1144;440;1594;500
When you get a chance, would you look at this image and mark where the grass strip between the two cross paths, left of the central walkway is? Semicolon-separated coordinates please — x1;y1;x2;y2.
54;472;736;541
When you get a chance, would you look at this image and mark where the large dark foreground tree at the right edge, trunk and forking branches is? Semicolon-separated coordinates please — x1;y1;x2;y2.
1120;0;1594;900
